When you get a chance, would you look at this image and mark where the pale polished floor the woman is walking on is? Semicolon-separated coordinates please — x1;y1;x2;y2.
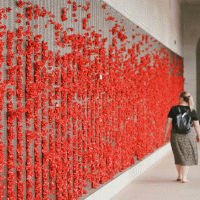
111;143;200;200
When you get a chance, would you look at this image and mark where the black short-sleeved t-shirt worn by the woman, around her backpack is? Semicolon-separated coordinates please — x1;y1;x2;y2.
168;105;198;127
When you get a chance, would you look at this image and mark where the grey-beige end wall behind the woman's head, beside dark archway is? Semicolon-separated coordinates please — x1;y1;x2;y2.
181;6;200;117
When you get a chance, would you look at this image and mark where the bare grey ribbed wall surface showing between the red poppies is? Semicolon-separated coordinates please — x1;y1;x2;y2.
0;0;182;199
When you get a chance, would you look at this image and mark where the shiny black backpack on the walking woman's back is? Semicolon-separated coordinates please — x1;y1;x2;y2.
175;107;192;134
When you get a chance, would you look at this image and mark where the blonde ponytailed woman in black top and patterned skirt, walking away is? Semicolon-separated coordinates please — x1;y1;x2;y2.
165;92;200;183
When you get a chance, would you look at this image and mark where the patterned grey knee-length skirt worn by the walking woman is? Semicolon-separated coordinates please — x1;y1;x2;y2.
170;128;198;166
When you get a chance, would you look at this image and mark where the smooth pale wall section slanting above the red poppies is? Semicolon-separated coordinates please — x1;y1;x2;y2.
103;0;183;56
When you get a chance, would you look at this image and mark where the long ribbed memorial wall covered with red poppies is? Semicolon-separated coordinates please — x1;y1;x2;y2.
0;0;184;200
